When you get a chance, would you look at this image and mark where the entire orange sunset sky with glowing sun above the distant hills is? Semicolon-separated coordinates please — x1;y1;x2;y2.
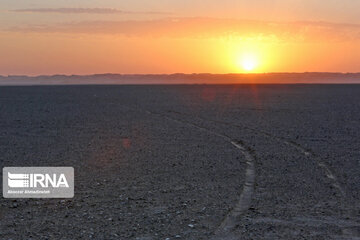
0;0;360;75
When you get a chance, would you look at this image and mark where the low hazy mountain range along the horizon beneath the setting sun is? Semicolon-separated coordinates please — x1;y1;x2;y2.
0;72;360;85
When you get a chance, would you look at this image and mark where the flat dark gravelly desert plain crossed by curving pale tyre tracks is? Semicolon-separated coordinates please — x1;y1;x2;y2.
0;85;360;240
